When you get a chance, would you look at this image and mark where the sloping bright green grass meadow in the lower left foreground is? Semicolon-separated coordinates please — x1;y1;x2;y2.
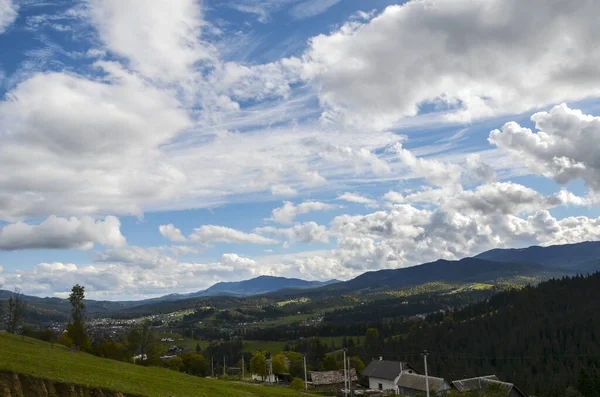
0;333;306;397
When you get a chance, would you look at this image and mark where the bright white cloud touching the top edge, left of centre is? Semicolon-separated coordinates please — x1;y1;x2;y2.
88;0;215;82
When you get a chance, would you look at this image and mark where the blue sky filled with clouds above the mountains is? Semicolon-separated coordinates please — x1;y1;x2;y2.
0;0;600;300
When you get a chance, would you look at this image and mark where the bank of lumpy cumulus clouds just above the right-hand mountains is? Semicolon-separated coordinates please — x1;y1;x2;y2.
330;204;600;274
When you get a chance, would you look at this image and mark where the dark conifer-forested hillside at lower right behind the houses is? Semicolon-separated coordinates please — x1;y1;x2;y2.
376;273;600;397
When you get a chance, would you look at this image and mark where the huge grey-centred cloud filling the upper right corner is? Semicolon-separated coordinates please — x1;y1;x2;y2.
303;0;600;128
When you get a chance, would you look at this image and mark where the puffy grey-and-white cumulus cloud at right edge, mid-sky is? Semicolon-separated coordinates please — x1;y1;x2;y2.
489;104;600;191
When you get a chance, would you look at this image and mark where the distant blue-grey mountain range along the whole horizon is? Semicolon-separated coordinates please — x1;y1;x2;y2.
0;241;600;314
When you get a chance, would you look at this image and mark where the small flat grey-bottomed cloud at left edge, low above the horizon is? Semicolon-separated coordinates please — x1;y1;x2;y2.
0;216;126;251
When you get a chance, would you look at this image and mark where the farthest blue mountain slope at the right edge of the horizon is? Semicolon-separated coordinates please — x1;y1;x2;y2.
475;241;600;272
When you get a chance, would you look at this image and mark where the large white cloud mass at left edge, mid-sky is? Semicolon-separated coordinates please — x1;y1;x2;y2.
0;62;191;221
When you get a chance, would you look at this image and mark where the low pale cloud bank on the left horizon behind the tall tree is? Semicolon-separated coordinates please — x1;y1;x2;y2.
5;250;286;300
